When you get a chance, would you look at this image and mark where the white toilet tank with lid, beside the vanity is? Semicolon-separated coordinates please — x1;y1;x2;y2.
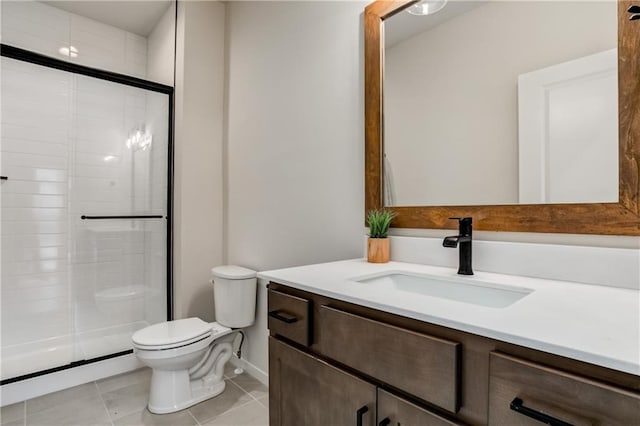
211;265;258;328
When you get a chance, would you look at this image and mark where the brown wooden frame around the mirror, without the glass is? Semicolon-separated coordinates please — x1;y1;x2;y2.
364;0;640;236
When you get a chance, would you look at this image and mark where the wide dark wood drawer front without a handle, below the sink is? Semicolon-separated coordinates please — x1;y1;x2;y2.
318;306;460;413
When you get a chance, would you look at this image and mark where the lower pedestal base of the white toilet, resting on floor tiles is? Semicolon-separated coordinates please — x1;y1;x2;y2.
147;370;226;414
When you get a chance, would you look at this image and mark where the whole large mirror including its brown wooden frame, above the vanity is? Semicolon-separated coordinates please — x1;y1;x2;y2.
365;0;640;235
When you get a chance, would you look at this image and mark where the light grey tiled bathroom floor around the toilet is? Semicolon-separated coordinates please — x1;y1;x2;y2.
0;365;269;426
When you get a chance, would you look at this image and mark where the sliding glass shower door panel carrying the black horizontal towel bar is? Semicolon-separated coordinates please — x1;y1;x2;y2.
69;76;169;359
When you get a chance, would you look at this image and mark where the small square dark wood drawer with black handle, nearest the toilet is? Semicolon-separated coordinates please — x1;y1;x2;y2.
268;289;311;346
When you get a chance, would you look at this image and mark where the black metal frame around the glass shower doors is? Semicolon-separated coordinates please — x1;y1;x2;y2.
0;44;174;385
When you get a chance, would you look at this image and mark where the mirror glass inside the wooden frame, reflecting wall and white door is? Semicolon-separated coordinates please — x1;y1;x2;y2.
384;0;618;206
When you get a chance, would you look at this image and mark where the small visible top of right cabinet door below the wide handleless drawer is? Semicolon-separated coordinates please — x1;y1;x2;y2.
378;389;462;426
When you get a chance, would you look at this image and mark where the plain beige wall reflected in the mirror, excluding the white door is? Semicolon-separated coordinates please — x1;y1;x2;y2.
384;1;617;206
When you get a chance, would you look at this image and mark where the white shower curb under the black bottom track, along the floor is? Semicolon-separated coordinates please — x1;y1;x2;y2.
0;354;142;407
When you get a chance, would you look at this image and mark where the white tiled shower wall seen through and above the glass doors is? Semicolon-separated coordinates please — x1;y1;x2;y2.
0;1;168;378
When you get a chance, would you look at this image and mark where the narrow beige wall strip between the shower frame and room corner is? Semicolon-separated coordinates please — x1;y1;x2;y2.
174;1;225;321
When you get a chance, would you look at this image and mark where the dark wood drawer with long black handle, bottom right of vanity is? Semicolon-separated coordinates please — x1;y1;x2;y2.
489;352;640;426
